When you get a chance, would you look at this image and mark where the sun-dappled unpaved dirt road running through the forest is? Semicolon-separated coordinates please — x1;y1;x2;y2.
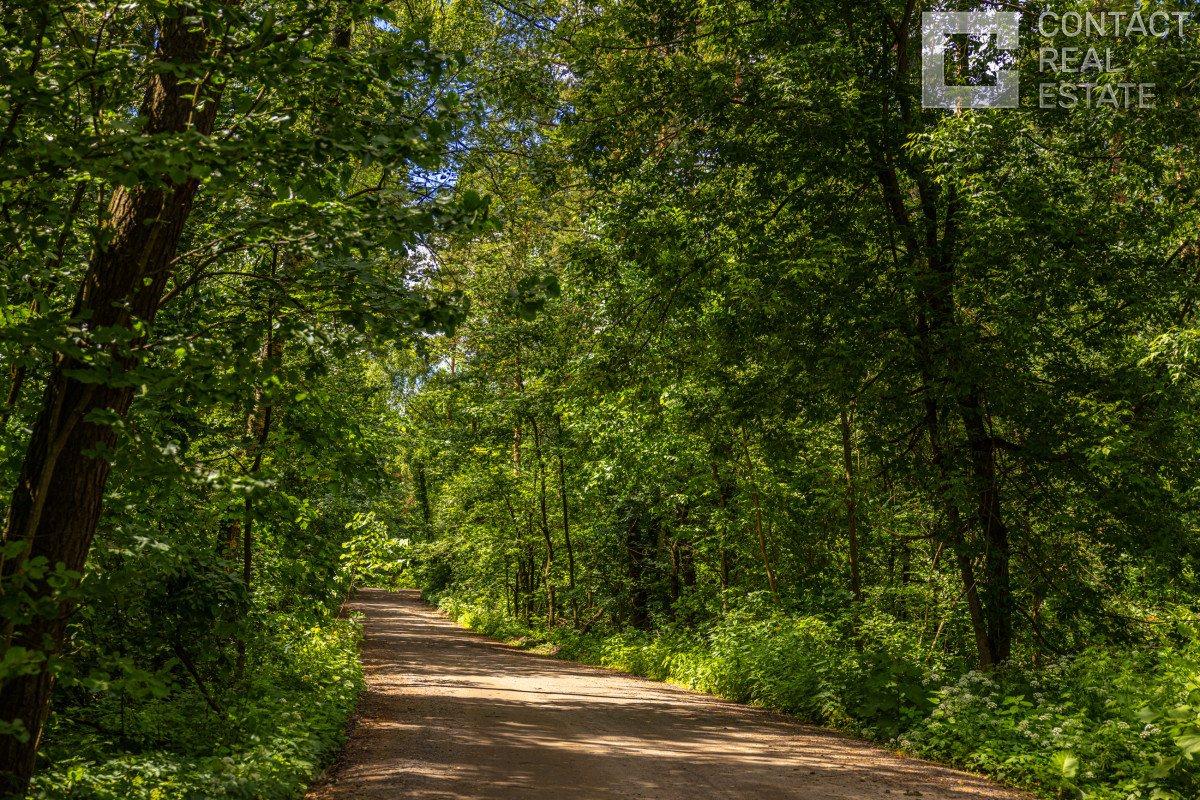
308;589;1022;800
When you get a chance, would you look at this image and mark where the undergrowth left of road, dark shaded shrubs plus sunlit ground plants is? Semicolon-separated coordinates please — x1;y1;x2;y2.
8;512;404;800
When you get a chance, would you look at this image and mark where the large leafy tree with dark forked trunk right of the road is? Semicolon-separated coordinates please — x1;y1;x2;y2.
400;2;1195;667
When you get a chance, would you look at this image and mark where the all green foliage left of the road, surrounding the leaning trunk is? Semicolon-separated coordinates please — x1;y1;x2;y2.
0;0;496;798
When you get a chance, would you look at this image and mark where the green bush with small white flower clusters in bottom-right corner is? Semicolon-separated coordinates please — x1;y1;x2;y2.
896;639;1200;800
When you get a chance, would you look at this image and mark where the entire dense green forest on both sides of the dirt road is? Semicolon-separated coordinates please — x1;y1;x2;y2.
0;0;1200;799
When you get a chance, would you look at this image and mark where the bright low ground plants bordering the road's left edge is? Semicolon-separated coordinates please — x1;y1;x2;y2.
30;615;362;800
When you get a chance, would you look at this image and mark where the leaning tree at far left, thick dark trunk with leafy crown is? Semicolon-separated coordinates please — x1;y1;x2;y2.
0;2;488;794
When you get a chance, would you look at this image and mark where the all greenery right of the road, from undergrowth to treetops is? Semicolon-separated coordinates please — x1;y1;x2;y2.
381;0;1200;798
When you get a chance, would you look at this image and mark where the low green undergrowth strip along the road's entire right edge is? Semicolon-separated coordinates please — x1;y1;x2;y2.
427;590;1200;800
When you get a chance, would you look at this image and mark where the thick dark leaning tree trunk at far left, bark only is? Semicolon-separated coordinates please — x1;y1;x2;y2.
0;7;225;796
